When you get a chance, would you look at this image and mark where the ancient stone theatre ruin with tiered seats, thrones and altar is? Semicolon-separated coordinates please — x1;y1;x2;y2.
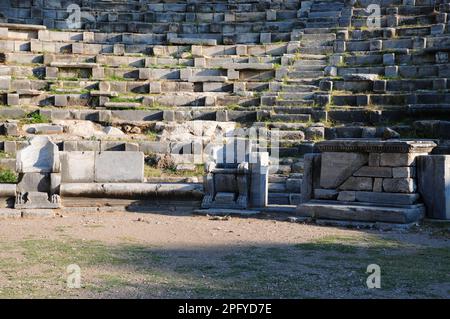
0;0;450;226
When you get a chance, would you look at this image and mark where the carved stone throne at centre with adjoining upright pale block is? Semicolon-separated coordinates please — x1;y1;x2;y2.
202;144;269;209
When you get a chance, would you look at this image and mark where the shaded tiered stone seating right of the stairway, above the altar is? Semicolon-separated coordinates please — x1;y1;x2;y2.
319;0;450;133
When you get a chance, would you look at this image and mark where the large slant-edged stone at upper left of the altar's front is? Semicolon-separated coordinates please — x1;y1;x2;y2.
320;152;368;189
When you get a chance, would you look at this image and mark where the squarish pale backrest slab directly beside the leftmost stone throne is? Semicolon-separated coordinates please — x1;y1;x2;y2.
60;152;96;183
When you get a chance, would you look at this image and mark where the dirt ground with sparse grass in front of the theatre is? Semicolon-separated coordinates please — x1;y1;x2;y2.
0;212;450;298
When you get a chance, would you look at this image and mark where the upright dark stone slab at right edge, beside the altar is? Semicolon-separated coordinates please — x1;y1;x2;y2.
417;155;450;220
